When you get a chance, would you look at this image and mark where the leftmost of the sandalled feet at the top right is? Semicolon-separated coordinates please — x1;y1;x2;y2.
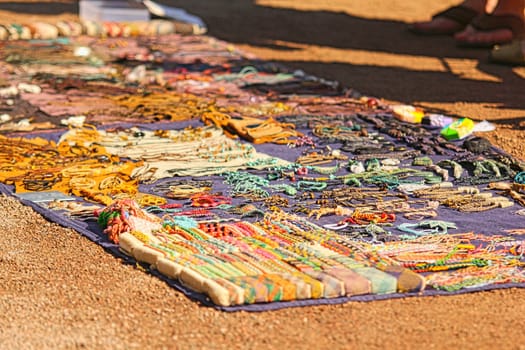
408;5;479;35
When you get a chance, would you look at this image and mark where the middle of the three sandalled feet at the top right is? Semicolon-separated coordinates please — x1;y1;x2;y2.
456;14;524;48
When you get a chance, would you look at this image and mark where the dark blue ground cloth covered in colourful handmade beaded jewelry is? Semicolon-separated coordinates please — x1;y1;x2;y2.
0;30;525;310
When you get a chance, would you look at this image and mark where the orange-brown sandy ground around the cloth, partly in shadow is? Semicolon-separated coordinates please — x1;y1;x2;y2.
0;0;525;349
